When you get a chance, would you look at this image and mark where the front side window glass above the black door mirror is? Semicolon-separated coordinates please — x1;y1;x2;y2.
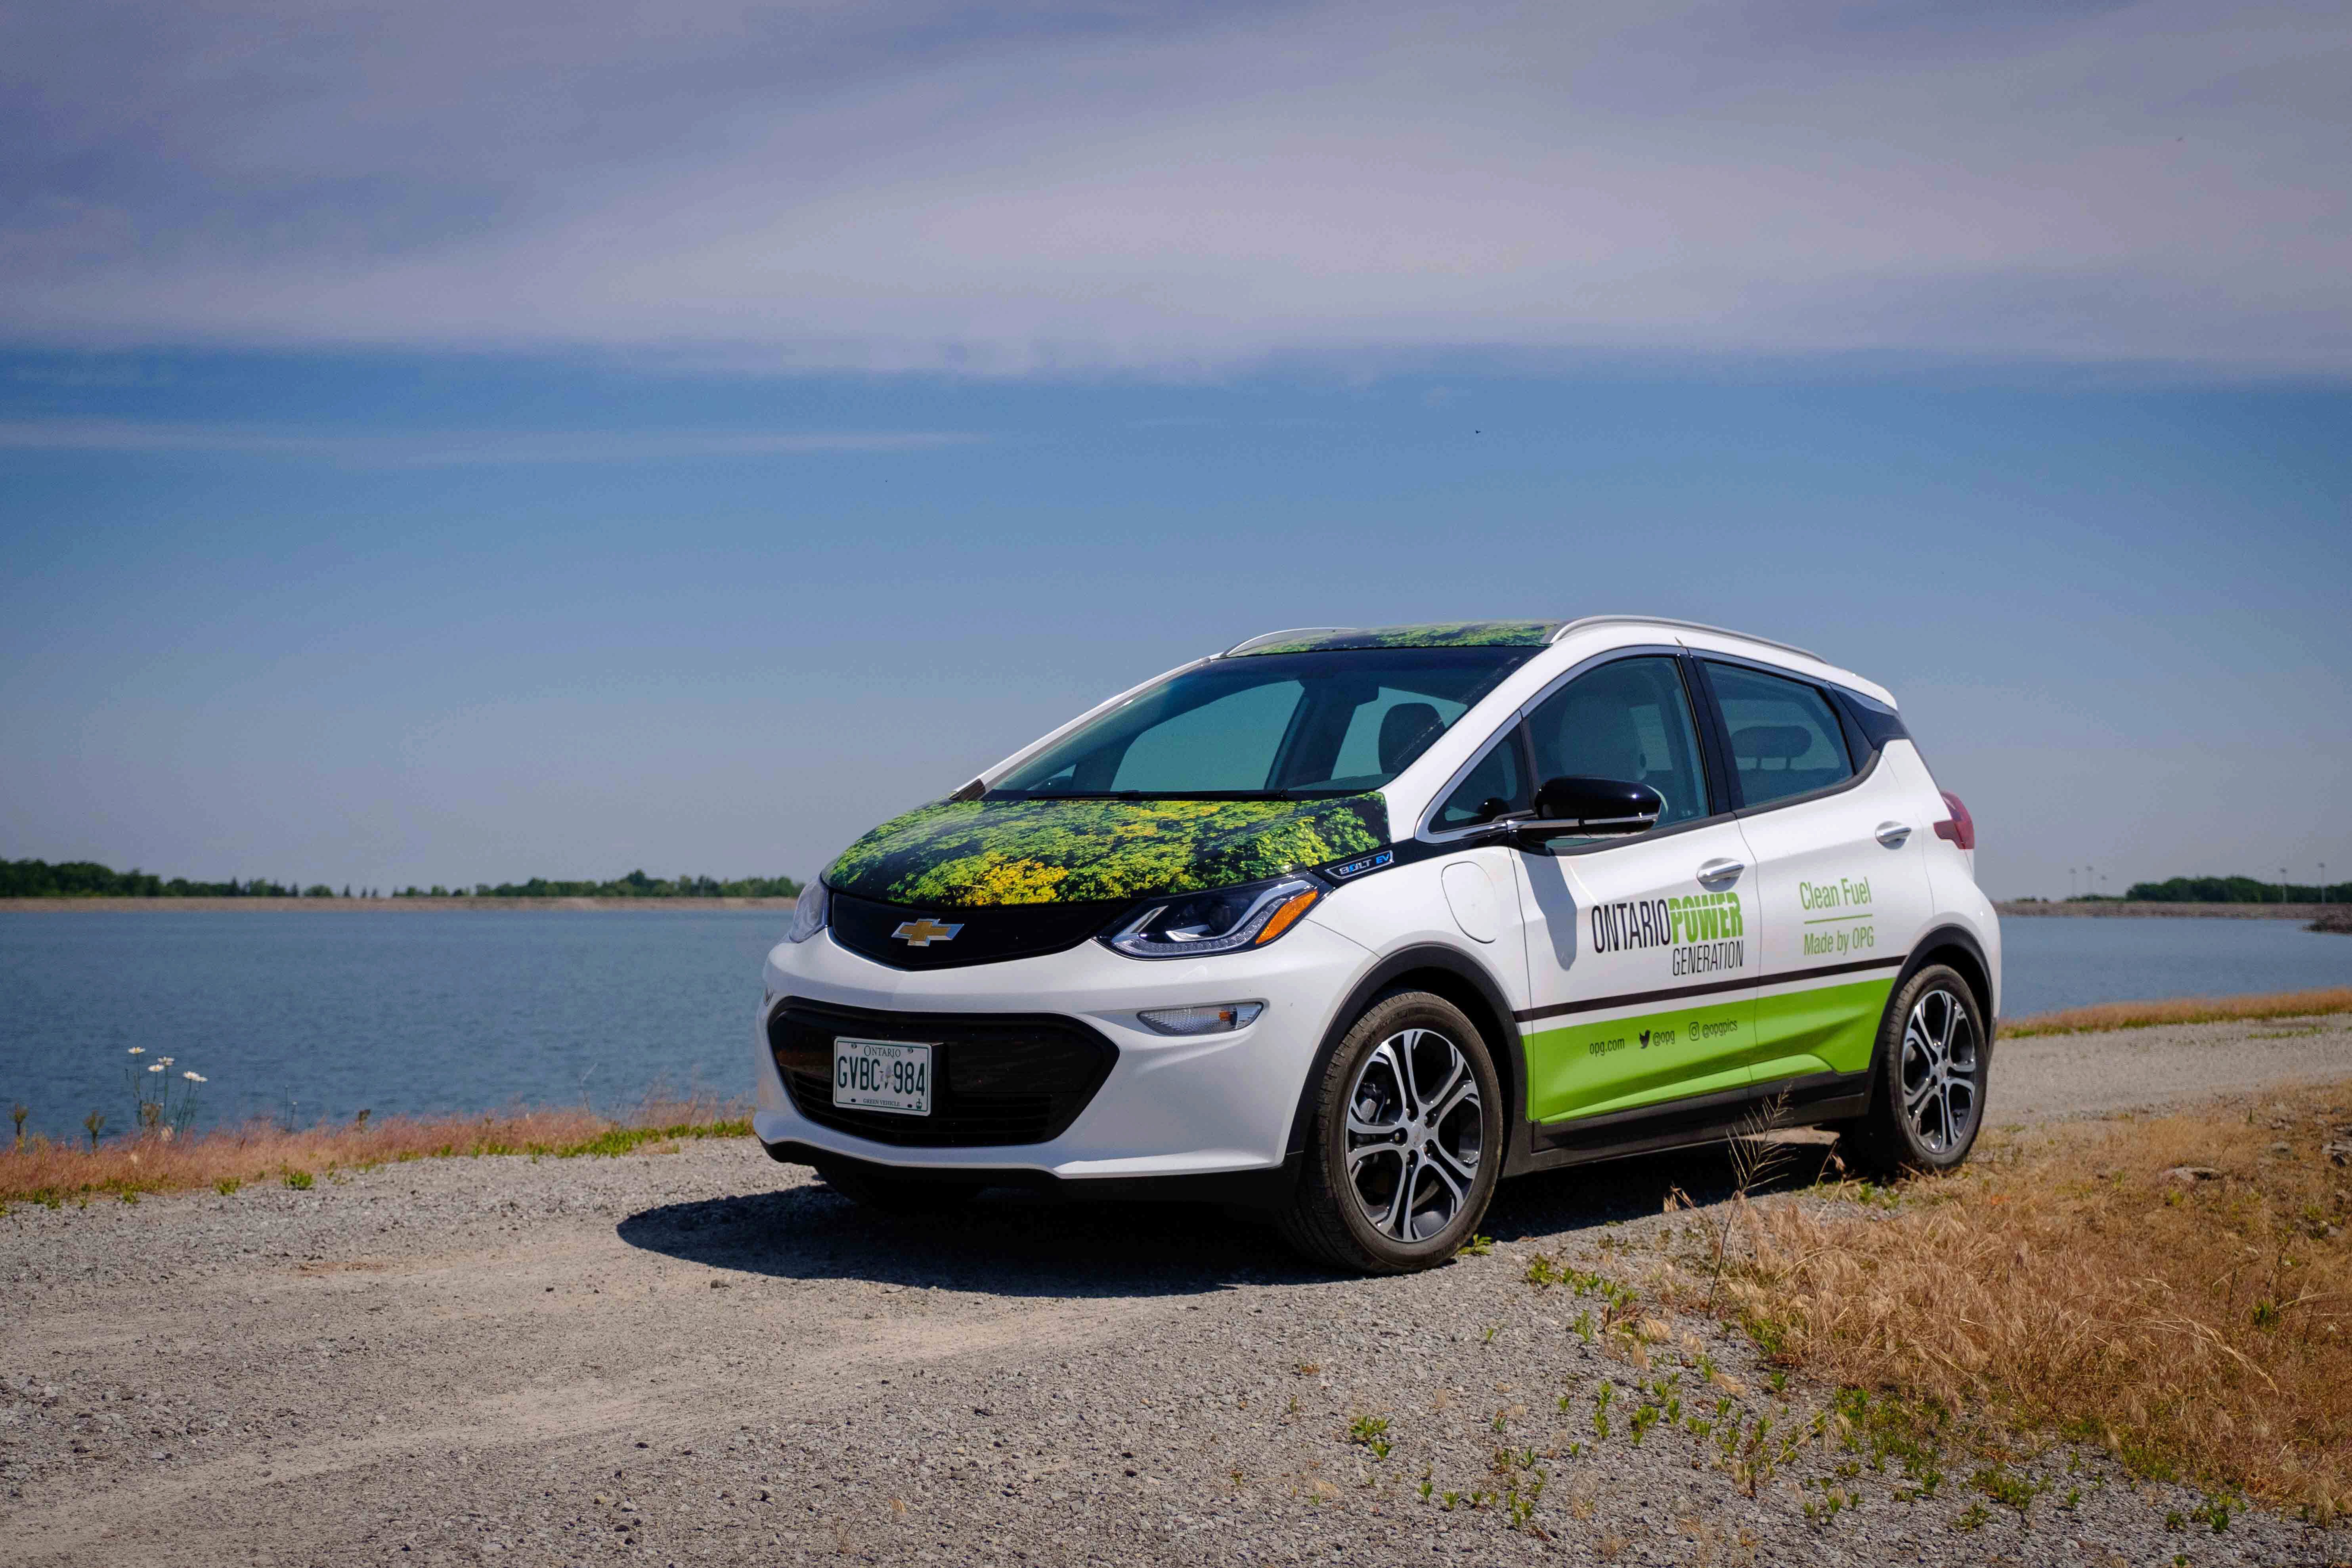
1526;656;1708;828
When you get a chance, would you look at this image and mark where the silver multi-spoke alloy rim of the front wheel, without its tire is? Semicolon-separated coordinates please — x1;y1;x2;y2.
1348;1030;1484;1241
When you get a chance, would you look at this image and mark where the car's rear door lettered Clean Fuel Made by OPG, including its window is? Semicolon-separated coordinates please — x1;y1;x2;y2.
1698;656;1933;1084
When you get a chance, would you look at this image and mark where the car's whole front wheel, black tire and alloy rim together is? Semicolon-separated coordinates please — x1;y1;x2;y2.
1277;992;1503;1274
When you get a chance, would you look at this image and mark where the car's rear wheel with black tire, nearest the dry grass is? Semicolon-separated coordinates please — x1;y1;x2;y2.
1839;964;1992;1176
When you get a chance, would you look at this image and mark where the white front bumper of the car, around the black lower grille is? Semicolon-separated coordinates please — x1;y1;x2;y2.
753;917;1371;1185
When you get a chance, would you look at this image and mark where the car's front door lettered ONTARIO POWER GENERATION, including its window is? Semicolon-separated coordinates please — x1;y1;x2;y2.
1517;651;1755;1124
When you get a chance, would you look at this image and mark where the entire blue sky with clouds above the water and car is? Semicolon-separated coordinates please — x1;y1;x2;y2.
0;0;2352;893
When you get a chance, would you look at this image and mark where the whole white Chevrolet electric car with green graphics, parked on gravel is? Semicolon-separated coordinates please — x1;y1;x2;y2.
755;616;2002;1272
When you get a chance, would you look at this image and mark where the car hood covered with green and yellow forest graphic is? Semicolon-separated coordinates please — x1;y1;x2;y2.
826;792;1388;907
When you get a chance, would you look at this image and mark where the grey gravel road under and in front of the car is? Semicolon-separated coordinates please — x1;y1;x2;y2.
0;1020;2352;1568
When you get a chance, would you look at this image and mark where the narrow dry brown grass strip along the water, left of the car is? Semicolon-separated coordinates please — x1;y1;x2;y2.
0;1100;750;1204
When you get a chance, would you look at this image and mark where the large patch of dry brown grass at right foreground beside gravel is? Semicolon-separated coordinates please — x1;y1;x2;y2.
1731;1084;2352;1518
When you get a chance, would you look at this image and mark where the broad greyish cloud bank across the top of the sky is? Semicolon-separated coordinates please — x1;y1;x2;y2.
0;0;2352;376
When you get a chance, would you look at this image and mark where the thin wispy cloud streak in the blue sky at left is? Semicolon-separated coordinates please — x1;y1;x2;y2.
0;419;983;468
